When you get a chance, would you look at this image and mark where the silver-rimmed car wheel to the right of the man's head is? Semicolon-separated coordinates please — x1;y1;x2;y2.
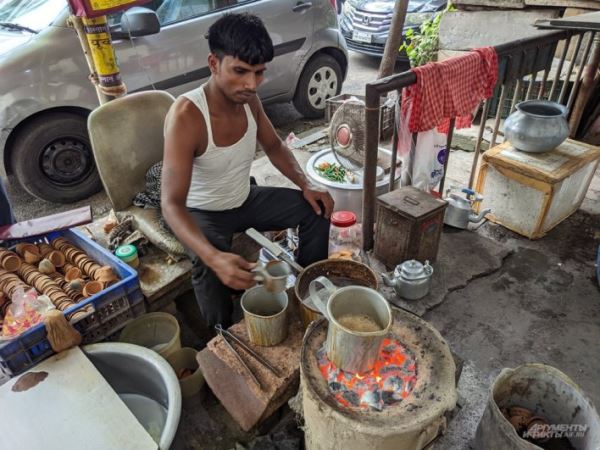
294;54;342;119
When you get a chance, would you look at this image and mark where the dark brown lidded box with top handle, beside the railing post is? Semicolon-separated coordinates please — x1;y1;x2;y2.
374;186;447;267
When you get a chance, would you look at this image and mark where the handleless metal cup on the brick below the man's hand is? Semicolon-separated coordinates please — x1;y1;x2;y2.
241;286;288;347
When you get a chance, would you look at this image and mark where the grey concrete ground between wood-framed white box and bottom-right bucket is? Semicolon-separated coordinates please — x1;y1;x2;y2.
424;200;600;450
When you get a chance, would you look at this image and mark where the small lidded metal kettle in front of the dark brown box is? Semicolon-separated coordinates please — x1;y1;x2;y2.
381;259;433;300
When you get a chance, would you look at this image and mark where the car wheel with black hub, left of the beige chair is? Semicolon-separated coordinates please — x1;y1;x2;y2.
11;113;102;203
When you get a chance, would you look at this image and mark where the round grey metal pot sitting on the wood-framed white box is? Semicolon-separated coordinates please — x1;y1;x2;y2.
504;100;569;153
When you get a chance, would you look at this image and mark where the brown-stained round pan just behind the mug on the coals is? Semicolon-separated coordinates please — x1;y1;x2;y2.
294;259;379;329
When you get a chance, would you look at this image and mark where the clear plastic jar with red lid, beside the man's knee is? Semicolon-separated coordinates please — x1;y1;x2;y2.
329;211;362;259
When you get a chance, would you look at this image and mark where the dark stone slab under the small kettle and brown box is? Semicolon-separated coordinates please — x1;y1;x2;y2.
370;227;511;316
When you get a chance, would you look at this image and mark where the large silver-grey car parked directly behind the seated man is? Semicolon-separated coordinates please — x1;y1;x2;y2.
0;0;348;203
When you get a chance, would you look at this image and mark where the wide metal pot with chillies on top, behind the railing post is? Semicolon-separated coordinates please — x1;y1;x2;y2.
306;149;399;222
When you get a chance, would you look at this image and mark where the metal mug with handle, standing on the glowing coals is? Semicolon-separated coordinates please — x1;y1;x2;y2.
309;277;393;373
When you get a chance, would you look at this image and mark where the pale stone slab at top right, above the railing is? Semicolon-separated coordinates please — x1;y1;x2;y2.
439;9;558;50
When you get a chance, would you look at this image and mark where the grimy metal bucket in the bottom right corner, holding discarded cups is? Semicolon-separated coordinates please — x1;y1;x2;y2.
474;364;600;450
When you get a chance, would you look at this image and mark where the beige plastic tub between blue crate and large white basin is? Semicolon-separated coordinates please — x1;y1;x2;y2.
119;312;181;359
